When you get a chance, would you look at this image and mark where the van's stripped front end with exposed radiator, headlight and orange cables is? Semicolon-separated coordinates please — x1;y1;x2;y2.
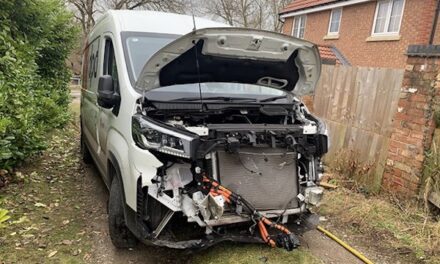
132;99;328;250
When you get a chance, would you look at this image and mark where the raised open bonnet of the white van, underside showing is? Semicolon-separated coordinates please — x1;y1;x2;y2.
135;28;321;96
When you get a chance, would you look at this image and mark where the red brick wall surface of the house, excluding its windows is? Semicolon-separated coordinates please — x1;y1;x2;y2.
283;0;440;68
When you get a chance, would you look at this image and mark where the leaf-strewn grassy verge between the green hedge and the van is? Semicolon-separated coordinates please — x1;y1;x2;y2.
0;122;91;263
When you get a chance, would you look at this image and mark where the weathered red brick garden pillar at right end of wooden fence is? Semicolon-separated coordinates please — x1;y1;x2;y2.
383;54;440;195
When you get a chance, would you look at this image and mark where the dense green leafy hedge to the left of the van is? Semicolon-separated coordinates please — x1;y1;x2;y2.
0;0;78;169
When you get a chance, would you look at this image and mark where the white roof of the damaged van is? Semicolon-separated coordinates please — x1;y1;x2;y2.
96;10;229;35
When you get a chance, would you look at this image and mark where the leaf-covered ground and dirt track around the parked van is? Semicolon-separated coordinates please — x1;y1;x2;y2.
0;96;412;263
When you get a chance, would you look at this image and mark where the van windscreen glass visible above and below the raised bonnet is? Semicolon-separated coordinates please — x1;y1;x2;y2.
122;32;290;100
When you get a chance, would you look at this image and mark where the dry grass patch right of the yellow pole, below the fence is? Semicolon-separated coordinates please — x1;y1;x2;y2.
319;188;440;263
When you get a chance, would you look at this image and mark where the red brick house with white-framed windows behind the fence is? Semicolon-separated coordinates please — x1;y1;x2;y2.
280;0;440;68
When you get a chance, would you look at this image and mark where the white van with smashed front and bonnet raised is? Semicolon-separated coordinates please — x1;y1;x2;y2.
81;11;327;250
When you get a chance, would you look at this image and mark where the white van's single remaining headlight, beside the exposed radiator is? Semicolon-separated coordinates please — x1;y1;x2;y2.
132;114;198;159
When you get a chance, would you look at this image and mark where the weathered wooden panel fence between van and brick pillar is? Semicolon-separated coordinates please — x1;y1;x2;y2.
313;65;404;190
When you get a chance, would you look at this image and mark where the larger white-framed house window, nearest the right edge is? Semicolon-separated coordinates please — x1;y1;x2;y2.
373;0;404;35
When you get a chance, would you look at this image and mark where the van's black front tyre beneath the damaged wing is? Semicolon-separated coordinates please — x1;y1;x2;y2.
108;177;137;248
